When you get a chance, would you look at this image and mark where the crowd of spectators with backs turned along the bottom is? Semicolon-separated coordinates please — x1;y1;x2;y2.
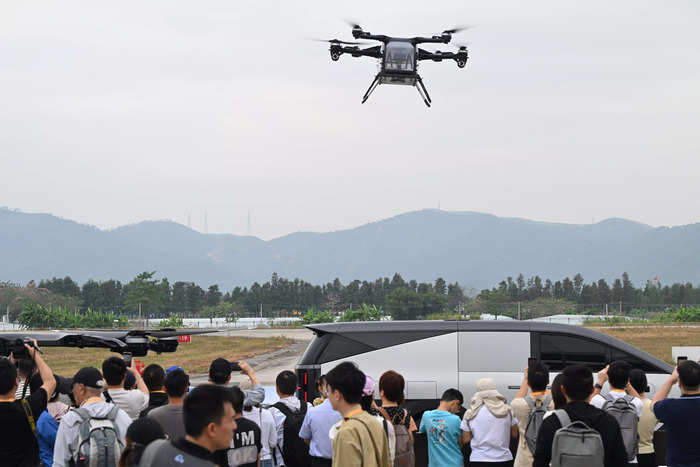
0;342;700;467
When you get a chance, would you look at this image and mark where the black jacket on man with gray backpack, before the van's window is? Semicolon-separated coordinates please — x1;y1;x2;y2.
532;402;627;467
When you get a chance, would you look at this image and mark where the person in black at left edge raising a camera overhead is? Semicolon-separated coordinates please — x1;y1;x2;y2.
0;341;56;466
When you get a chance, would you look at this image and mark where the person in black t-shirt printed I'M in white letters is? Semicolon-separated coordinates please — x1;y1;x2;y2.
215;387;262;467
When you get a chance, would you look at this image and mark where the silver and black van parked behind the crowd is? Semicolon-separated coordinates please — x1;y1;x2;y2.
296;321;673;413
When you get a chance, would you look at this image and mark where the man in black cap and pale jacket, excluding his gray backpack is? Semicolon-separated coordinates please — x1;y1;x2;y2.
53;367;131;467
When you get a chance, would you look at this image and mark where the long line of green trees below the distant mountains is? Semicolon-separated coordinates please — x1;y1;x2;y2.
0;271;700;319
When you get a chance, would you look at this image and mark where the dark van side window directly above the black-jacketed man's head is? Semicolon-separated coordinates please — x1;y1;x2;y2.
540;333;608;371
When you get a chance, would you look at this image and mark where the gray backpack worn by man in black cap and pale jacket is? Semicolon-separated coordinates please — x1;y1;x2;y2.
73;406;124;467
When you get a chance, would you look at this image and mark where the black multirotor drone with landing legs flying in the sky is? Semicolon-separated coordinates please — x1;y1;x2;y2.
317;24;469;107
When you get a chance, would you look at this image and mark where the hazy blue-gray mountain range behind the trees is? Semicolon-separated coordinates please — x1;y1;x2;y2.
0;209;700;290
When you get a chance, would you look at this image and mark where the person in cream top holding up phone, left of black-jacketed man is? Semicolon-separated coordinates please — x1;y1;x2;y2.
510;361;552;467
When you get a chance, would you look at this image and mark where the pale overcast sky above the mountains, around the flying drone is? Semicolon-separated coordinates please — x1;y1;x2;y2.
0;0;700;238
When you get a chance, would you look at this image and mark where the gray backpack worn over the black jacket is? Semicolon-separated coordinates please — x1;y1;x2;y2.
551;409;604;467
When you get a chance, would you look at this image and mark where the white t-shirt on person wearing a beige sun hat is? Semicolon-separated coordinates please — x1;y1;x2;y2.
460;405;518;462
